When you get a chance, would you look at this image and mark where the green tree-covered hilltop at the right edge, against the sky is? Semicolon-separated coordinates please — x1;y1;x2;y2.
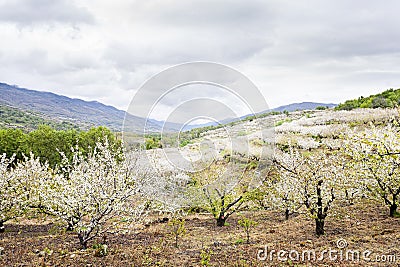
336;88;400;110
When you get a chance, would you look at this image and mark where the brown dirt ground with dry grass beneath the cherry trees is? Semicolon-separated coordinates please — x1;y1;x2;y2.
0;200;400;266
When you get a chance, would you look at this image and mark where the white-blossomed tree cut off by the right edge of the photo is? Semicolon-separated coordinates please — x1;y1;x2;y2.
345;125;400;217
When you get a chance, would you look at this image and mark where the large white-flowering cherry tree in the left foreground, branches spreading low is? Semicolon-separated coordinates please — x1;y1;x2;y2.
37;140;143;248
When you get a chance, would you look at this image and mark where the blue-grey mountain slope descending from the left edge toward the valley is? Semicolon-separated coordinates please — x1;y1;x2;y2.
0;83;159;132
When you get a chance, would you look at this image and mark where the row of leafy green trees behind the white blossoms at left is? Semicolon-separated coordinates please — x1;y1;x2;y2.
0;125;120;167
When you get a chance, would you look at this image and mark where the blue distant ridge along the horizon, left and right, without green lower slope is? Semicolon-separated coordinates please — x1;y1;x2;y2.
0;82;336;133
